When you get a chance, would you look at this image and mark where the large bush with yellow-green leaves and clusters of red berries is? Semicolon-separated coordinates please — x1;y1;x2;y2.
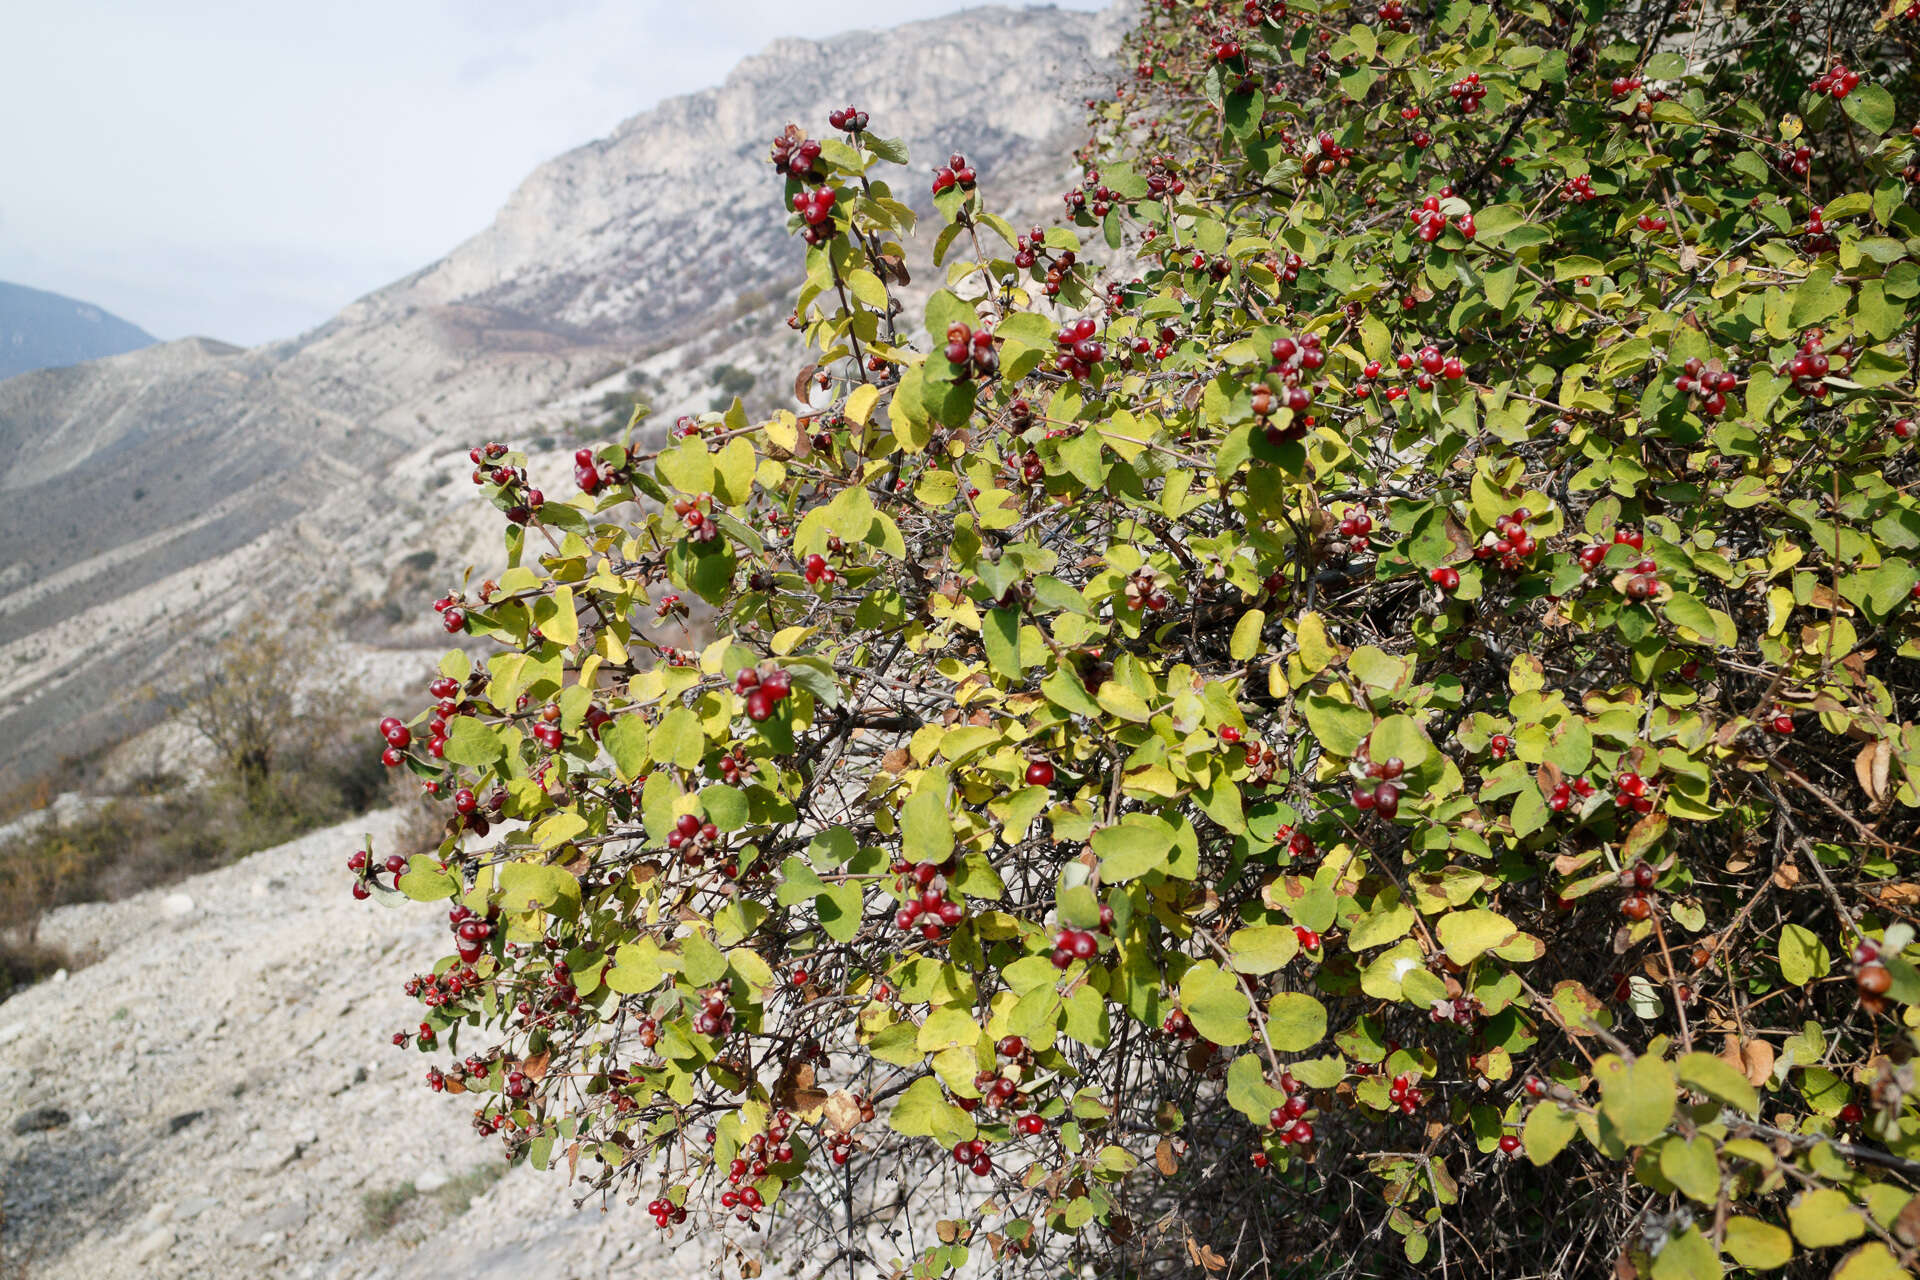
371;2;1920;1276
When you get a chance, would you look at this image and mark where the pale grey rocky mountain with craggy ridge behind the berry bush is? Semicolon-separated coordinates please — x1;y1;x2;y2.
0;8;1123;802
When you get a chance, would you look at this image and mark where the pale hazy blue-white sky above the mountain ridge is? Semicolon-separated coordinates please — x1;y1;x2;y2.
0;0;1104;345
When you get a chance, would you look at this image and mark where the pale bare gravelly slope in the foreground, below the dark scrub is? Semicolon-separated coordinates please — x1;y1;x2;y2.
0;812;748;1280
